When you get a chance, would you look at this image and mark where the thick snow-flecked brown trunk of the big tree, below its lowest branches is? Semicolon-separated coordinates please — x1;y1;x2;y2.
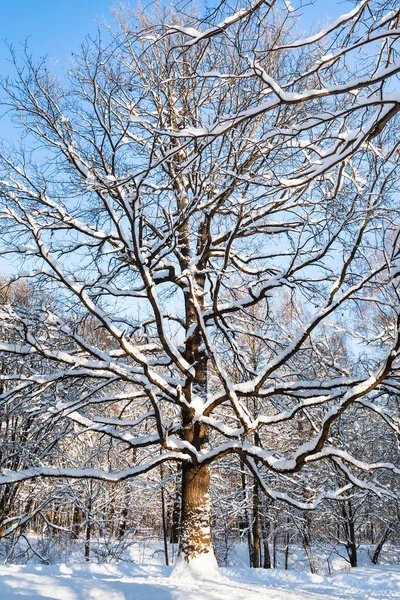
181;465;212;562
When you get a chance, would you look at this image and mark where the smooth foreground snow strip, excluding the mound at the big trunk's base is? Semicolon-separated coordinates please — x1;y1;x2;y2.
0;563;400;600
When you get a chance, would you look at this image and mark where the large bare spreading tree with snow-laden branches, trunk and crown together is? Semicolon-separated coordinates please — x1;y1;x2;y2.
0;0;400;561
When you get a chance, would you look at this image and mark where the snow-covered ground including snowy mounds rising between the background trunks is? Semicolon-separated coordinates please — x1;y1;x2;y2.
0;535;400;600
